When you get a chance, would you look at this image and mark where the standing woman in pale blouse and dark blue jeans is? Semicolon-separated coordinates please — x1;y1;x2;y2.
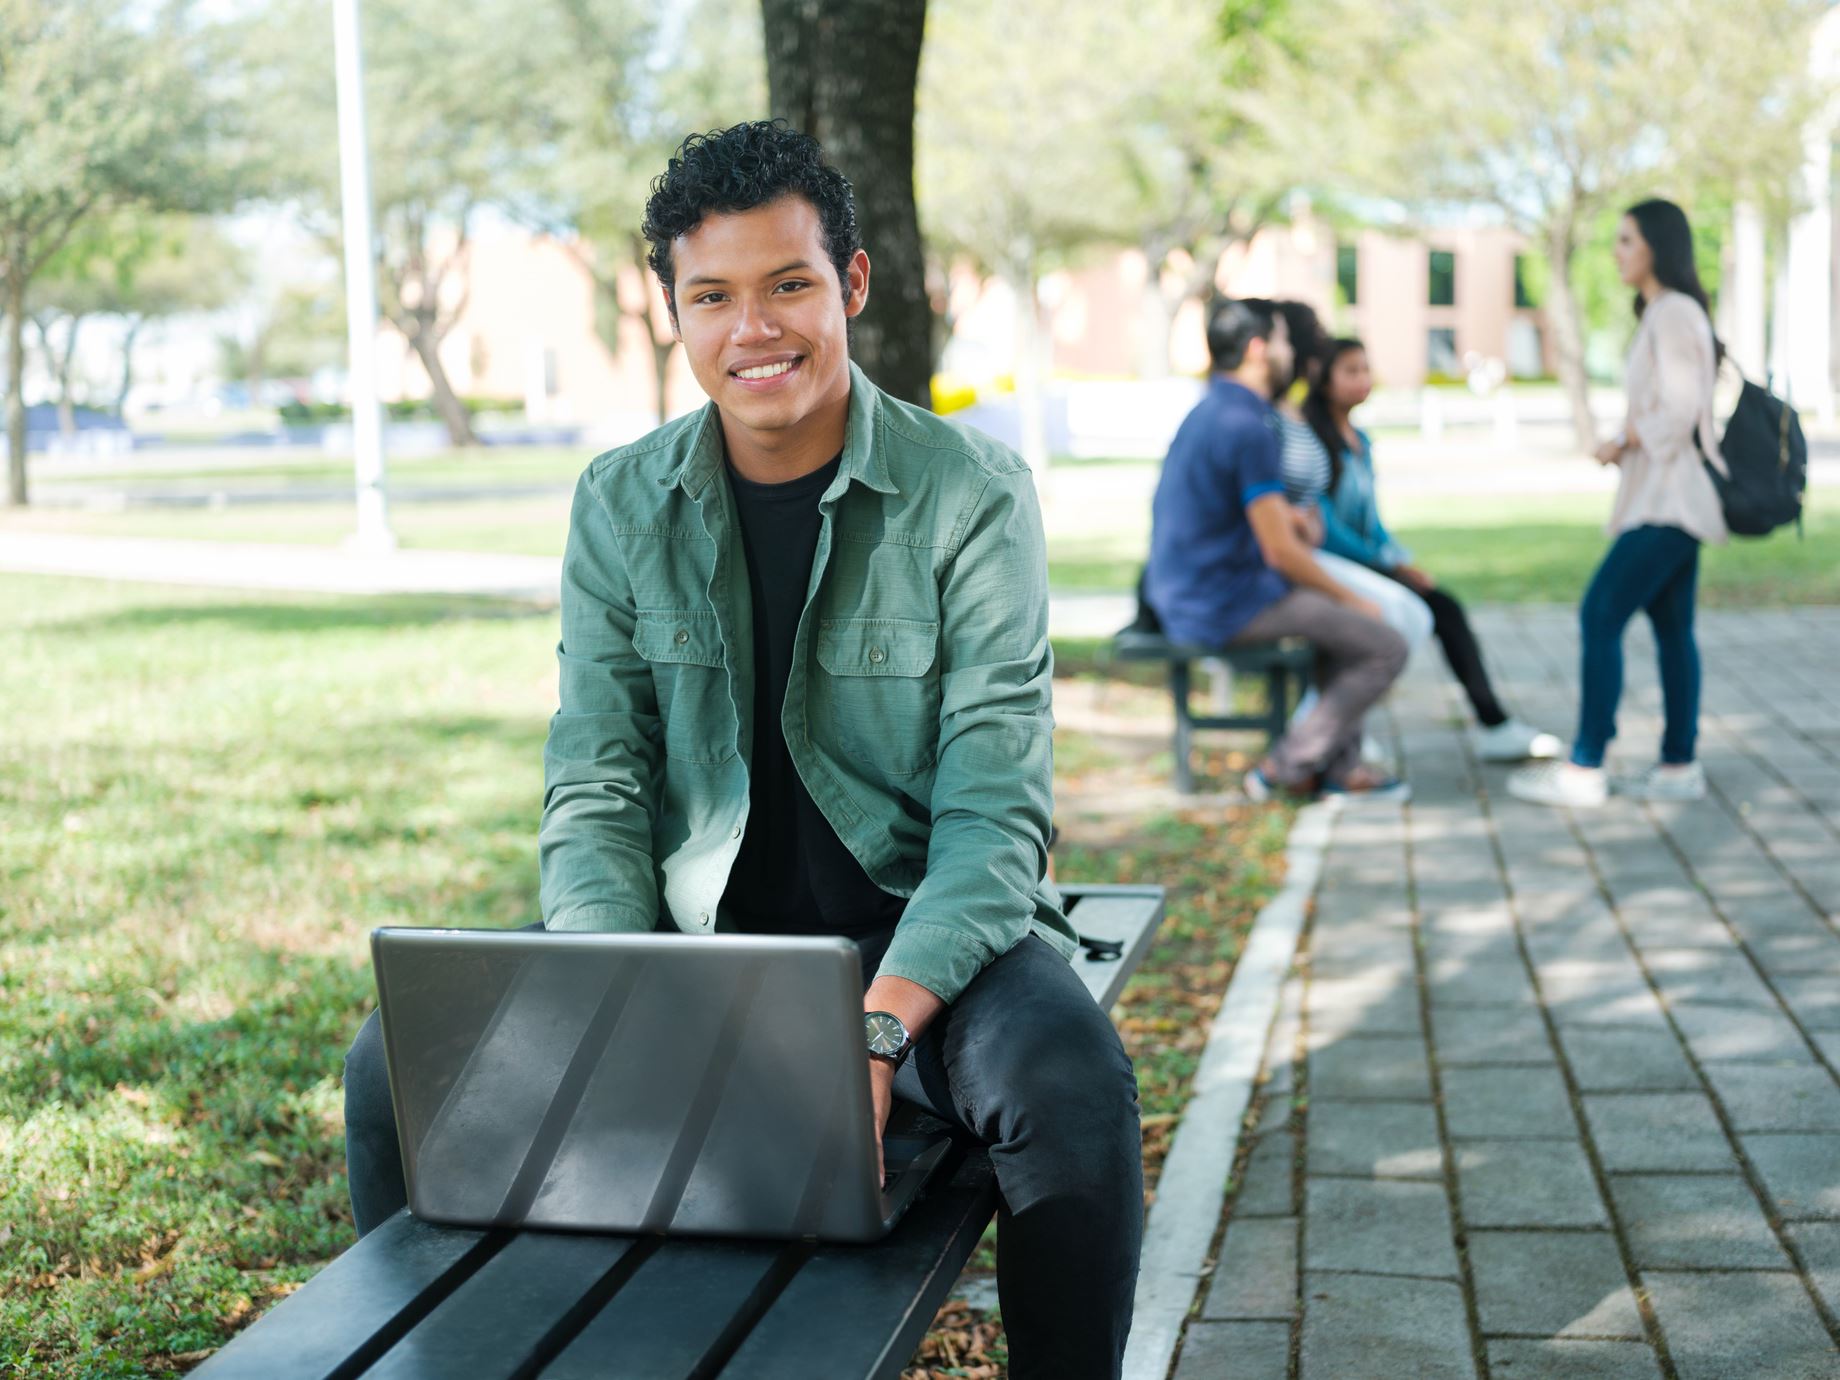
1507;201;1726;808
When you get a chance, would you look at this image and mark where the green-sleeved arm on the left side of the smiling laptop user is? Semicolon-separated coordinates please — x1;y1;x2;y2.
537;471;661;933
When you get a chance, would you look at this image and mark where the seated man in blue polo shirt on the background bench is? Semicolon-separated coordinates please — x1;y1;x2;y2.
1146;298;1409;800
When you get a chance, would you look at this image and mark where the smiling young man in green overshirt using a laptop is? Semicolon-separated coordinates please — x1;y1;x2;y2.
333;123;1143;1376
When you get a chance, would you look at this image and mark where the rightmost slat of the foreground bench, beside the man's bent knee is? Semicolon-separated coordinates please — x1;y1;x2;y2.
721;1154;997;1380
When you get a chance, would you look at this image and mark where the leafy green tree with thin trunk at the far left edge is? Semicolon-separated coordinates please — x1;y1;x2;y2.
0;0;248;504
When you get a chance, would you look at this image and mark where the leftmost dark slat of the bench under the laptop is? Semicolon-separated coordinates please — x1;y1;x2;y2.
193;1211;510;1380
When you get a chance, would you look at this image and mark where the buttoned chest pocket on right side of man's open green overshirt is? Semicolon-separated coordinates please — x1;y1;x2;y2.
817;618;938;776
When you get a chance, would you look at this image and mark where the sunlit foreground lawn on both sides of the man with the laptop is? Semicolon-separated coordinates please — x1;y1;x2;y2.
0;574;1284;1380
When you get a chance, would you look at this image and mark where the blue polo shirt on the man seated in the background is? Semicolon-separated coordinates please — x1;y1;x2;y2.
1146;377;1290;646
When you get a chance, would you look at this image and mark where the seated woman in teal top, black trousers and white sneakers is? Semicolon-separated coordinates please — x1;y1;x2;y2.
1286;340;1560;762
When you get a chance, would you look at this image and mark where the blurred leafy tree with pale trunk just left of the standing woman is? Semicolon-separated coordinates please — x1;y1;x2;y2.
1339;0;1823;443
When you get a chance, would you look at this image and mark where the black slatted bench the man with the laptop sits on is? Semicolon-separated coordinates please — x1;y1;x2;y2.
193;887;1163;1380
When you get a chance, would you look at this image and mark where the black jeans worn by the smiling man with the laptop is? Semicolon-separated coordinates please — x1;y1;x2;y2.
344;937;1143;1380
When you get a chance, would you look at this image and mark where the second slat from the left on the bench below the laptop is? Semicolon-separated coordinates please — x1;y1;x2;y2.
364;1231;651;1380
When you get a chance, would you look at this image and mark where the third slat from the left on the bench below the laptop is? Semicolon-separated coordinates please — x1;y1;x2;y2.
543;1242;791;1380
